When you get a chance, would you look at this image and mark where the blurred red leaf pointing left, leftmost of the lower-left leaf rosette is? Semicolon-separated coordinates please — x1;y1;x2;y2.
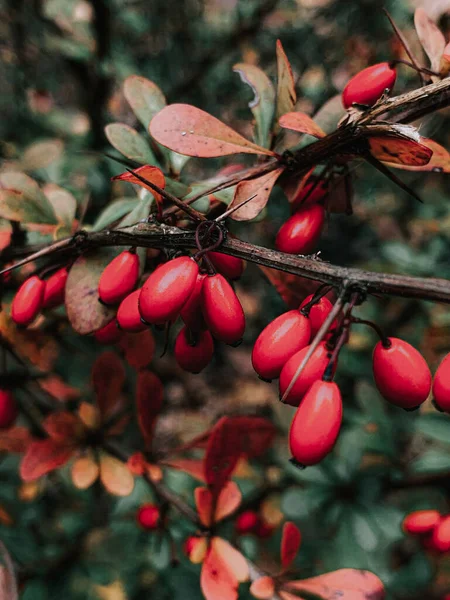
20;439;74;481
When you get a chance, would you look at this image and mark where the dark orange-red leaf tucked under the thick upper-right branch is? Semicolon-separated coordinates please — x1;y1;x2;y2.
368;135;433;167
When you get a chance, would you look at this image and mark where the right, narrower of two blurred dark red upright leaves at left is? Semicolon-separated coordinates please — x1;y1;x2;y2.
136;371;164;448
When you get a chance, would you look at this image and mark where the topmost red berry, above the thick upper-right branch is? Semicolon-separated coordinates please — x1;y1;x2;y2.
342;62;397;108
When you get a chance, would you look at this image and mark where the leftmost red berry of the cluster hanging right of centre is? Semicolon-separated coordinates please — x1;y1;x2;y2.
252;310;311;380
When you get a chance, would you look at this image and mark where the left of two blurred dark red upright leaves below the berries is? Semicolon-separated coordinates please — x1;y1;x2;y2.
91;351;125;421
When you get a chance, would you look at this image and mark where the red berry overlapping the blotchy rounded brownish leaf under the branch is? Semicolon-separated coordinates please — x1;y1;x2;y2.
98;250;139;304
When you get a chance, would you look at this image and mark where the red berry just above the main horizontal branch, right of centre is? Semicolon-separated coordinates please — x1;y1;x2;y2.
275;204;325;254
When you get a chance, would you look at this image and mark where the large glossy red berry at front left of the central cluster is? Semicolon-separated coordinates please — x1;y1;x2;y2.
139;256;198;324
